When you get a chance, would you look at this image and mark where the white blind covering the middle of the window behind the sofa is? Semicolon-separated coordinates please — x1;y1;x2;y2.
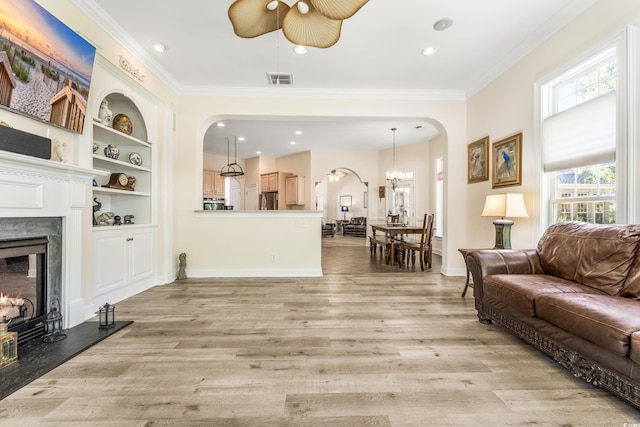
543;91;616;172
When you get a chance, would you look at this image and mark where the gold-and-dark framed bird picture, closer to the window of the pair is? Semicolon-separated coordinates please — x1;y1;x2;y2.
492;132;522;188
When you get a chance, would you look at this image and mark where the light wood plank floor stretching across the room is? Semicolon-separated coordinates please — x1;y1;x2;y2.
0;236;640;427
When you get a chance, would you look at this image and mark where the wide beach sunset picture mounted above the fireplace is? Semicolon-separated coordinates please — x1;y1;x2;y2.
0;0;96;133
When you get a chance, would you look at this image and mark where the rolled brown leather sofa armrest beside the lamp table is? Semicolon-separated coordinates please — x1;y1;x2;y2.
465;249;544;322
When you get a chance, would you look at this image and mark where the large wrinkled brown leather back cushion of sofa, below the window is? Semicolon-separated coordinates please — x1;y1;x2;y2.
538;222;640;295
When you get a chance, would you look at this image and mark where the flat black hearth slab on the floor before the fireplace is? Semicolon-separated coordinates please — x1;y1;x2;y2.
0;321;133;400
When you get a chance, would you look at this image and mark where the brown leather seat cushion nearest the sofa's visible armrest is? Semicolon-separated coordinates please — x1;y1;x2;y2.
482;274;604;317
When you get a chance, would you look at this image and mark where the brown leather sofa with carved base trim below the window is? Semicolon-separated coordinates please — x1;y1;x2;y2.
465;222;640;408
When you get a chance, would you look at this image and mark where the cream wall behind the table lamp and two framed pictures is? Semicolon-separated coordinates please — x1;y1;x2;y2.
464;0;640;248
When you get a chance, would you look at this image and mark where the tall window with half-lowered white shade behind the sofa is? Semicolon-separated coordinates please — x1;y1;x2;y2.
541;47;617;224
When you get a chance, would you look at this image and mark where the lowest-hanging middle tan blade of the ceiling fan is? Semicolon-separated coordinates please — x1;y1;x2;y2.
282;5;342;48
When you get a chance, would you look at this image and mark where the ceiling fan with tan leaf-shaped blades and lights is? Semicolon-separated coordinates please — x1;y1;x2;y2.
229;0;369;48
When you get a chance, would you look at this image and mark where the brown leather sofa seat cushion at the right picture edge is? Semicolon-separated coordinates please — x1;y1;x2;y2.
535;294;640;356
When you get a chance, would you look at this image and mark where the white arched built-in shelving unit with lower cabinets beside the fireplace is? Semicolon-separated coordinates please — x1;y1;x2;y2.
91;83;157;303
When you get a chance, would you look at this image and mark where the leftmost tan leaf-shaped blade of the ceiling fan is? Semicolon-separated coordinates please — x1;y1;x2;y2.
228;0;290;38
